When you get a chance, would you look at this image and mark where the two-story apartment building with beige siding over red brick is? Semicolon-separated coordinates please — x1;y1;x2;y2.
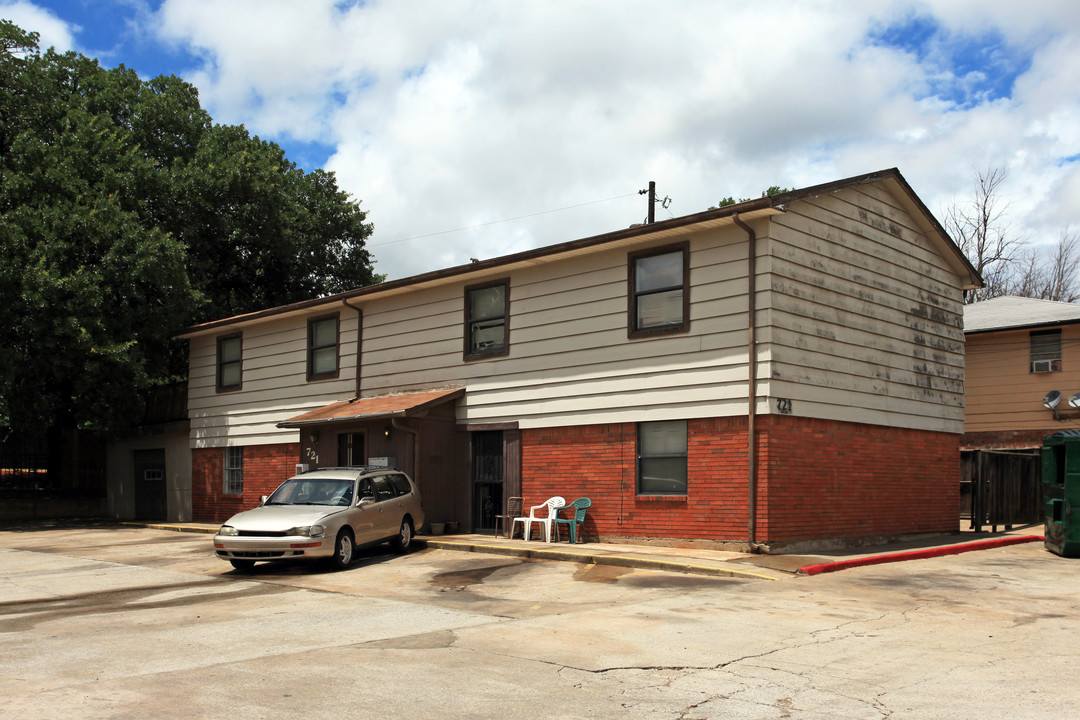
174;169;980;549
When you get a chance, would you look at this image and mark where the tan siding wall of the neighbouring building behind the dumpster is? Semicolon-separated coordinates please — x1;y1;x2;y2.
963;325;1080;435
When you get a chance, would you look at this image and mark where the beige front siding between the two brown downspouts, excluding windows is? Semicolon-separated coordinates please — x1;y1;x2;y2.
362;229;746;427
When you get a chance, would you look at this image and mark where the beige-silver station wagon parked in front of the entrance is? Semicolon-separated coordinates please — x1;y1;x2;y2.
214;465;423;570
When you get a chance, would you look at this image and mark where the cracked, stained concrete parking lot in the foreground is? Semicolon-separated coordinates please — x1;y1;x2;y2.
0;527;1080;720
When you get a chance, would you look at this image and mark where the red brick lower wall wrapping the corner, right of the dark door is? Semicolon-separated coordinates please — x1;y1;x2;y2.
522;416;960;543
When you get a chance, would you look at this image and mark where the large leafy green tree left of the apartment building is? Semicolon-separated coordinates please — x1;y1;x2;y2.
0;21;378;433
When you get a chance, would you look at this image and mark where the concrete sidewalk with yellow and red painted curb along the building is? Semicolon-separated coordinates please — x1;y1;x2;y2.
121;522;1042;580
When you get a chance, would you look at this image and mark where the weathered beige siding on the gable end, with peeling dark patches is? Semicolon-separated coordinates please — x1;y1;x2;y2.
767;186;963;433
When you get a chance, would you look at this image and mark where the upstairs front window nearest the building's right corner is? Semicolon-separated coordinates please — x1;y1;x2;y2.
630;243;690;337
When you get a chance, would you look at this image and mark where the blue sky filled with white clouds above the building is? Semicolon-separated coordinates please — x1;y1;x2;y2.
0;0;1080;279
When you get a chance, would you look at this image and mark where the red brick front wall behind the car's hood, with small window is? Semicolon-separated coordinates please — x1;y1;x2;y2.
191;443;300;522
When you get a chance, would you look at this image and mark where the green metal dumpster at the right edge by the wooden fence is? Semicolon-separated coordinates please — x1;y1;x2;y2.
1042;430;1080;557
